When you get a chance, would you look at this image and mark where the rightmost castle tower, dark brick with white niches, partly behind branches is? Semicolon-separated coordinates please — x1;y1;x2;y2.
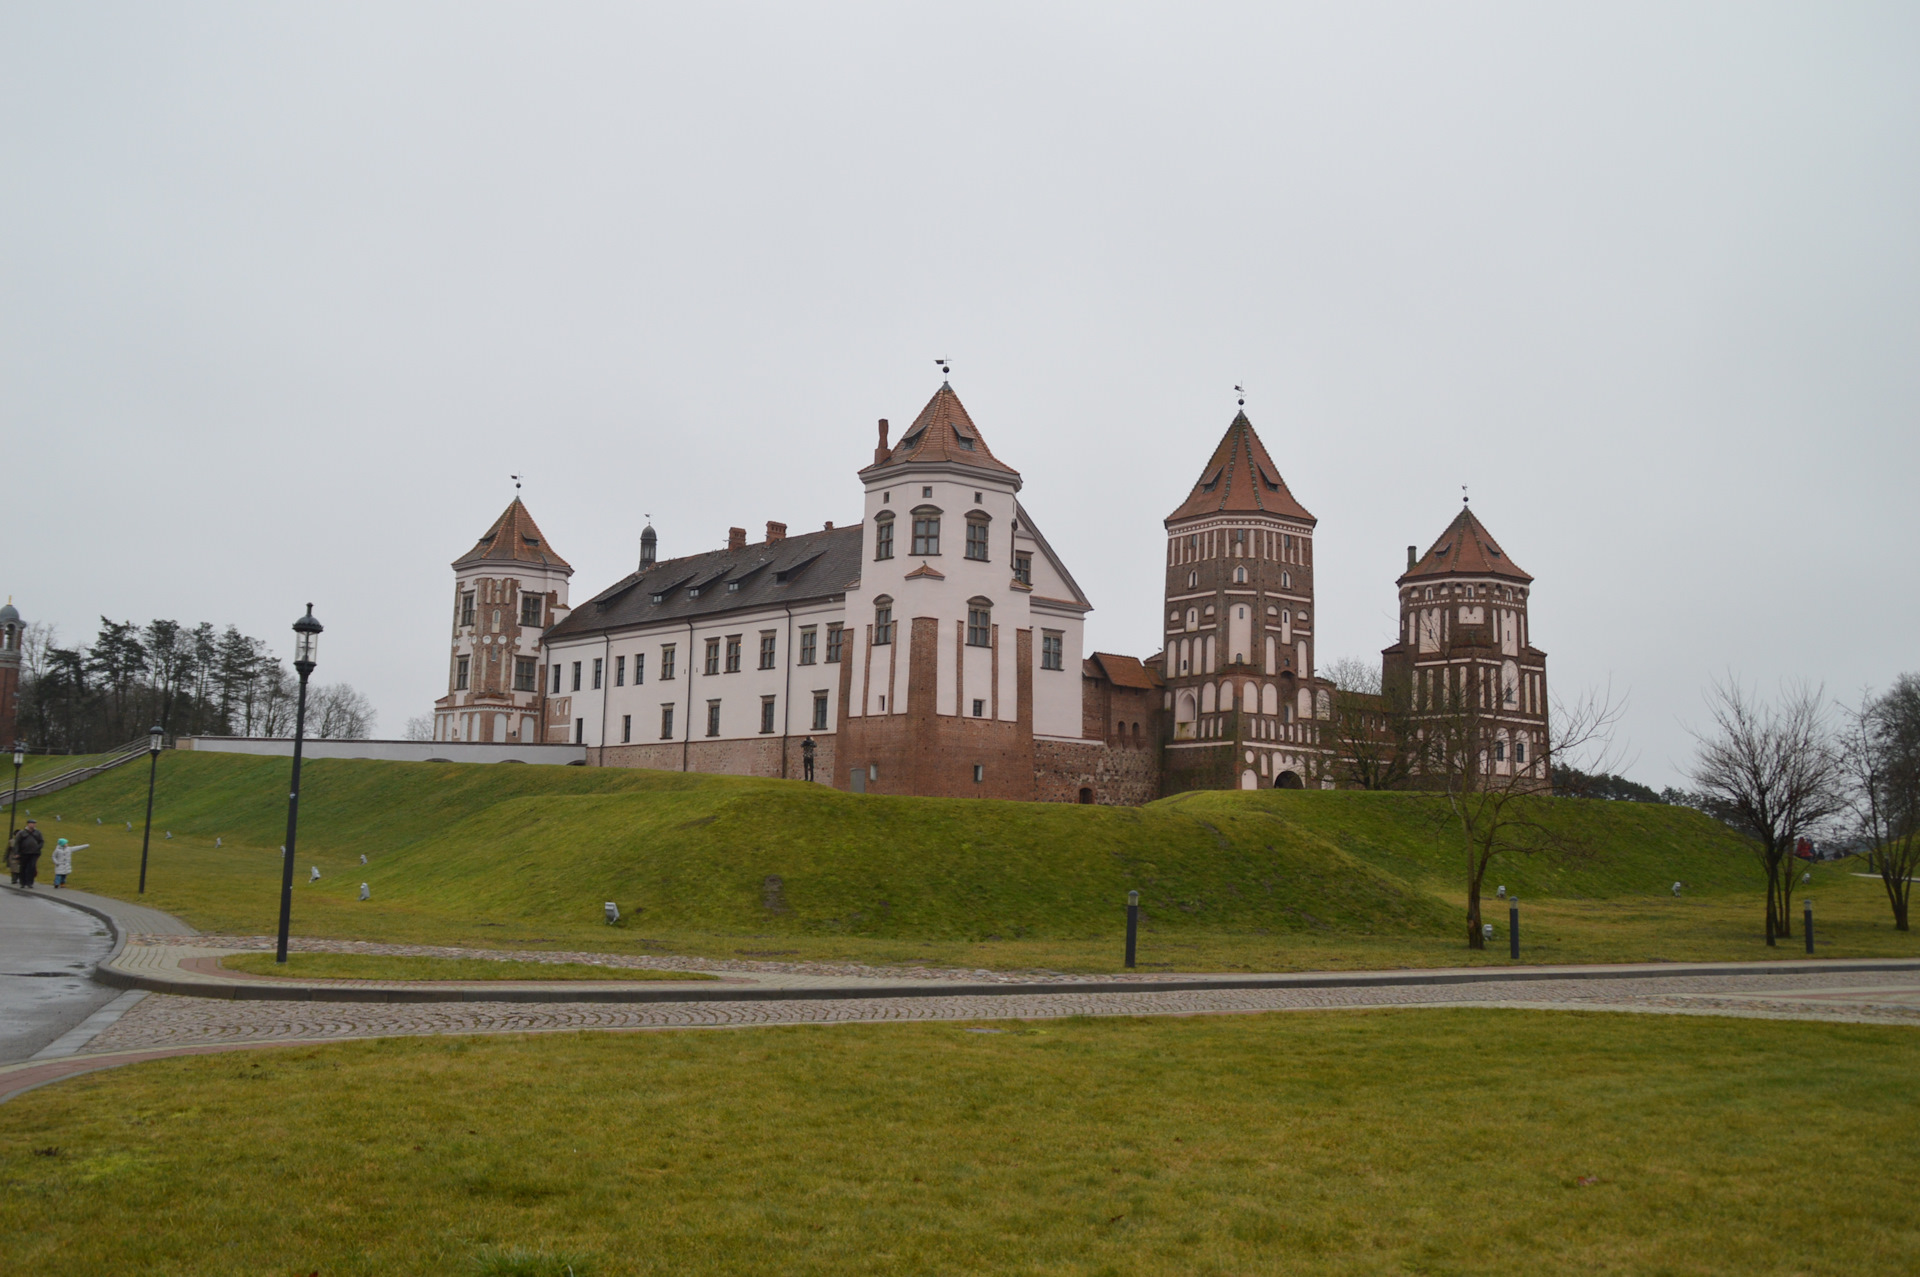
1380;505;1551;789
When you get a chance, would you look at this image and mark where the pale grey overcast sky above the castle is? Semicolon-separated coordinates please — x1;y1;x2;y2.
0;0;1920;785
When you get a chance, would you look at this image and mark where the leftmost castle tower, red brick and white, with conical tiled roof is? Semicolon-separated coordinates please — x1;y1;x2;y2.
434;497;574;745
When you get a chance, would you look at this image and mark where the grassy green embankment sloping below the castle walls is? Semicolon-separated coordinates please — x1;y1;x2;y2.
38;753;1920;970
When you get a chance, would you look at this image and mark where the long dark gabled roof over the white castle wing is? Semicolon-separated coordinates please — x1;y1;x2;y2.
547;524;862;641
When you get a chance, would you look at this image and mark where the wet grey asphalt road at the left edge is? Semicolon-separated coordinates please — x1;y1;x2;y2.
0;883;119;1064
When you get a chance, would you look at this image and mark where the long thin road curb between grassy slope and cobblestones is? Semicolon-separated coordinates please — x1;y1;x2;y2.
94;958;1920;1002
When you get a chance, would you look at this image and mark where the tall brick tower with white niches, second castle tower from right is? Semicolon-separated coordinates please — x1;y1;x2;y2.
1164;413;1332;793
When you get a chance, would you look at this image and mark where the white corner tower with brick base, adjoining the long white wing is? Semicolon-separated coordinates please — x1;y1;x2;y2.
833;384;1092;799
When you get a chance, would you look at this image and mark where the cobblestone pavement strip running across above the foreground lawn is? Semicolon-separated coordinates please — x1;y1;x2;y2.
88;972;1920;1054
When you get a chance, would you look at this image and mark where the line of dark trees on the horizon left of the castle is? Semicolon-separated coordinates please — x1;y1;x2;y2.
17;616;374;753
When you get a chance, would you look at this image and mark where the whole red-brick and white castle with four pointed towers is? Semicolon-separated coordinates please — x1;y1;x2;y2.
434;384;1548;805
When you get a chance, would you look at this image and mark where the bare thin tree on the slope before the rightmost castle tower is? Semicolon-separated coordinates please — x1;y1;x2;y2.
1413;682;1626;949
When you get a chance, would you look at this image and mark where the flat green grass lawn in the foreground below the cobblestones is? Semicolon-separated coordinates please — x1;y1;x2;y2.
0;1010;1920;1277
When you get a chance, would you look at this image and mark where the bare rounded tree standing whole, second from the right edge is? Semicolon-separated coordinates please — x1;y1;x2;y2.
1692;678;1845;945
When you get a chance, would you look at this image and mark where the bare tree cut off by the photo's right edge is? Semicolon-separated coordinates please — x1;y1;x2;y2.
1839;674;1920;931
